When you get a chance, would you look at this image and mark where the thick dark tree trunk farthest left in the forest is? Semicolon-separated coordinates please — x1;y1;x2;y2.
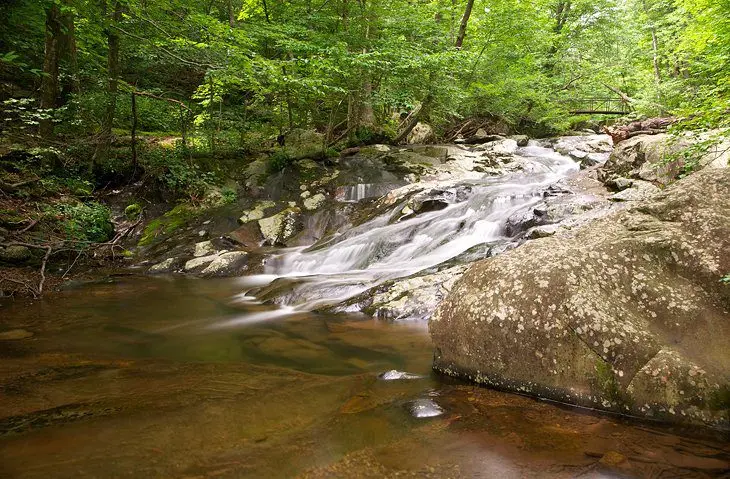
39;3;61;138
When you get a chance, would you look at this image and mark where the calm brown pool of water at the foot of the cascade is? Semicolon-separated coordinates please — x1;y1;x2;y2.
0;277;730;478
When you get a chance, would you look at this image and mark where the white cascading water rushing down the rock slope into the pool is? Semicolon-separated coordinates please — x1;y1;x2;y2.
236;143;578;311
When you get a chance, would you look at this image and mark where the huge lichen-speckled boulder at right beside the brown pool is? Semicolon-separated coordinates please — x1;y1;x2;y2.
430;169;730;427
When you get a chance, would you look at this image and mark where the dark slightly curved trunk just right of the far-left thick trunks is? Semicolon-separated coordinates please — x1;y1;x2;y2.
93;0;122;165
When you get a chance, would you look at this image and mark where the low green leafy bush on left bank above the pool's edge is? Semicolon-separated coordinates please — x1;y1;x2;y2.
49;202;114;243
